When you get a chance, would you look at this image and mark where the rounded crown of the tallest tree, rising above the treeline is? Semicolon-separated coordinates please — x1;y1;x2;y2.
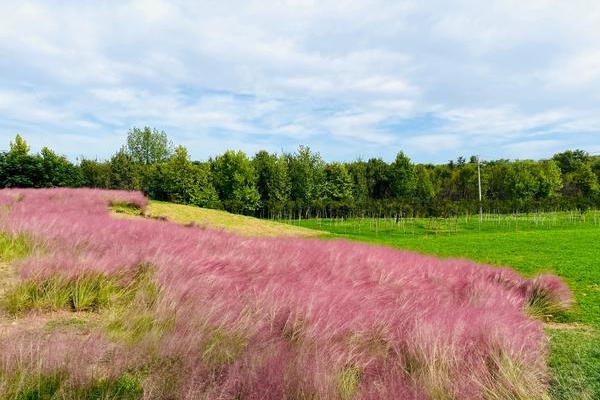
126;126;173;165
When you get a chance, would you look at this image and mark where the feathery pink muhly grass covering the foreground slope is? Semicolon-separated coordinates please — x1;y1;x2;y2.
0;189;571;400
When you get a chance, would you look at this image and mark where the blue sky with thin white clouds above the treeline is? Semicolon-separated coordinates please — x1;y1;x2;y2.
0;0;600;163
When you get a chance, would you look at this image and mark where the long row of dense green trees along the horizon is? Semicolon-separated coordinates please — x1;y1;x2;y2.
0;127;600;218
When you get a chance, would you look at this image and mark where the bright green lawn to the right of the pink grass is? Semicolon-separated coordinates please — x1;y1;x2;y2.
287;212;600;399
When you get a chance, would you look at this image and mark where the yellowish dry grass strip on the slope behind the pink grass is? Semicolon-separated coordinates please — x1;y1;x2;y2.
114;200;327;237
